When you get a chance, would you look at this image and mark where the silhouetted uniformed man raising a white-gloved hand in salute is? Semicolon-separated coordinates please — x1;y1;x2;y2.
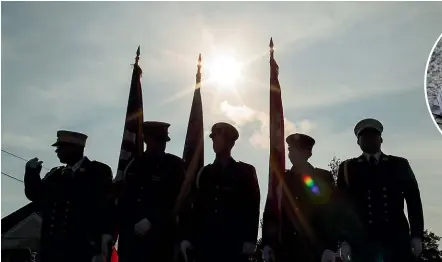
24;130;113;262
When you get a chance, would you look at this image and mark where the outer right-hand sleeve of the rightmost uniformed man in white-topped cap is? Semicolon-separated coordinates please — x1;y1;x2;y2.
401;159;424;238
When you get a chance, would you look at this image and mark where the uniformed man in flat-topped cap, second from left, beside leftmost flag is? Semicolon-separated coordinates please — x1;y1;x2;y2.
118;121;184;262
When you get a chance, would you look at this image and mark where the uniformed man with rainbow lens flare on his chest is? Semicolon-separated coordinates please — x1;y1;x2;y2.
263;134;346;262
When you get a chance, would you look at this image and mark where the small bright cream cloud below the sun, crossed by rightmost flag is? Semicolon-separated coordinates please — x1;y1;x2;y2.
220;101;314;149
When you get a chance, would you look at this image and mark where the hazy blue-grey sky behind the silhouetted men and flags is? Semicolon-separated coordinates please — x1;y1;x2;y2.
1;2;442;239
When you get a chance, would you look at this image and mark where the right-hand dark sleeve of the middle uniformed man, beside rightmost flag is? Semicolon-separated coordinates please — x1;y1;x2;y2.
243;166;261;243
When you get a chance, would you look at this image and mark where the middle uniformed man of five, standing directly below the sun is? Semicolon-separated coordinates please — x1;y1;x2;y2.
181;122;260;262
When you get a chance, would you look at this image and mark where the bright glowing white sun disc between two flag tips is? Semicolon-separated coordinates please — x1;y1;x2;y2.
207;55;241;86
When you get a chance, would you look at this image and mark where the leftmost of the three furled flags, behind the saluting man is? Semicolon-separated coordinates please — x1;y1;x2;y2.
111;46;144;262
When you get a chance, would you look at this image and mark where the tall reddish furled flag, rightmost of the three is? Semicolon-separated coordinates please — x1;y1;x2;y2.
262;38;285;248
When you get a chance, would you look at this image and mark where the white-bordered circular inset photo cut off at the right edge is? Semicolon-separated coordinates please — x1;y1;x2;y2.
425;34;442;133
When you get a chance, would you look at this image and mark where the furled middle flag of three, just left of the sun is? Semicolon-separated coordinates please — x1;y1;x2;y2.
175;54;204;215
